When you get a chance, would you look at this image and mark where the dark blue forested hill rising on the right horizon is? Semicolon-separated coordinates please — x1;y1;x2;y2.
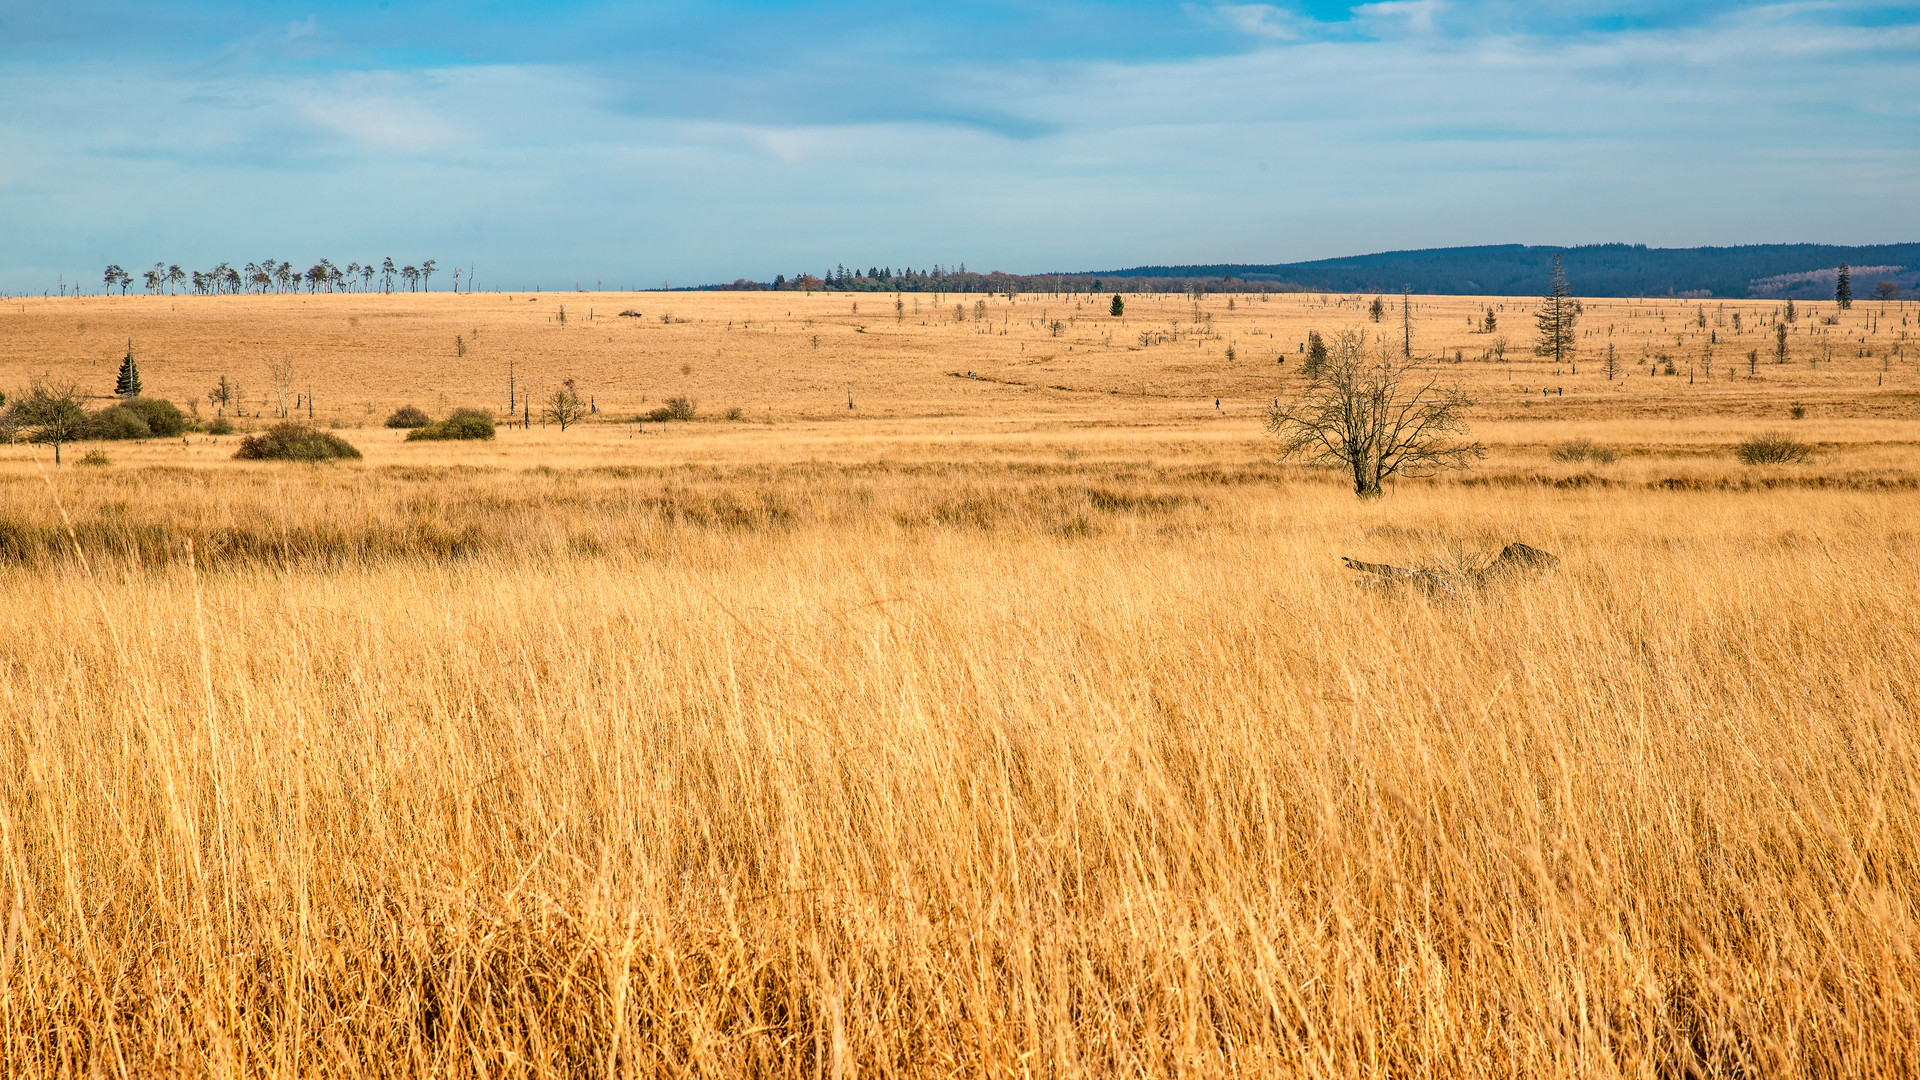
1098;244;1920;298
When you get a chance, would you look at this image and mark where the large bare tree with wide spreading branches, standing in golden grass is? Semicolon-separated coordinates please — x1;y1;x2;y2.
1267;331;1486;498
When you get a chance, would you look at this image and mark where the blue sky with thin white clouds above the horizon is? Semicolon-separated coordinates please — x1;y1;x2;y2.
0;0;1920;292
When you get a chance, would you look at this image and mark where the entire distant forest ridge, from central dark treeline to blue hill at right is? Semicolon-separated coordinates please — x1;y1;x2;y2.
701;244;1920;300
